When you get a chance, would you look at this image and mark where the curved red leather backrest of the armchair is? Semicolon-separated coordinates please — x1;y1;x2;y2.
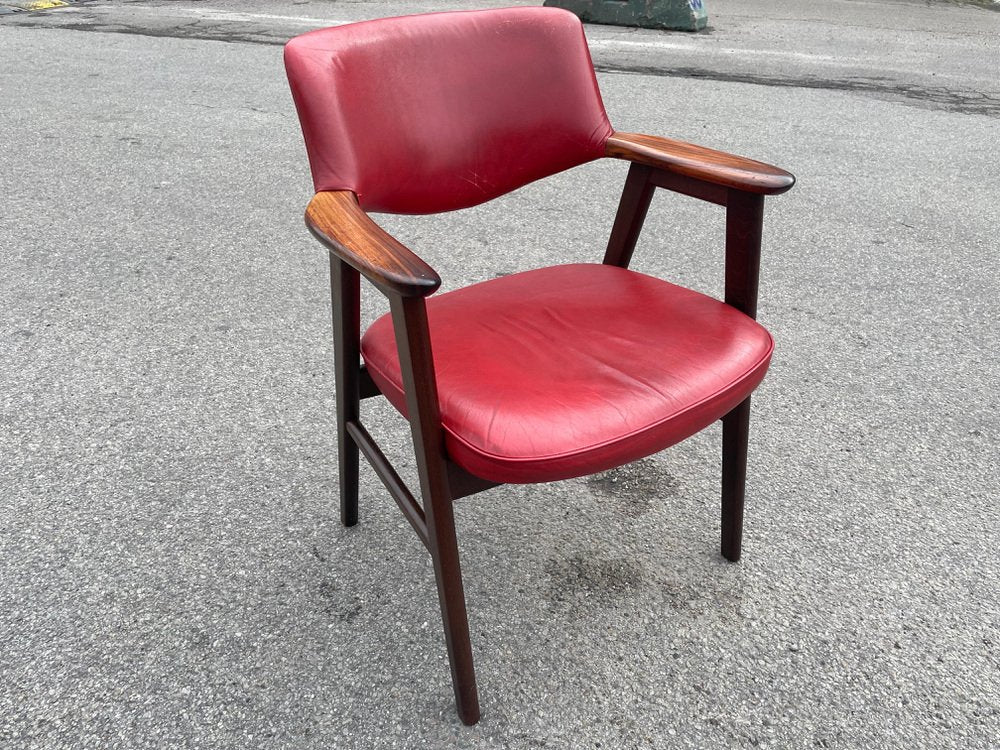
285;7;612;213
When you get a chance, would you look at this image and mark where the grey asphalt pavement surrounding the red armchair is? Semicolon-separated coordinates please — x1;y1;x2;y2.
0;0;1000;750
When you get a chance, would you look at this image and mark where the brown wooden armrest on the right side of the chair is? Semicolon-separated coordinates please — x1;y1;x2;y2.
604;132;795;195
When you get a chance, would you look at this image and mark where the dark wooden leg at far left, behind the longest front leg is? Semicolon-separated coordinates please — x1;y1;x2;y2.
330;253;361;526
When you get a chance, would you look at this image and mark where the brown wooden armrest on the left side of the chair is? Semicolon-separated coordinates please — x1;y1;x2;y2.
306;190;441;297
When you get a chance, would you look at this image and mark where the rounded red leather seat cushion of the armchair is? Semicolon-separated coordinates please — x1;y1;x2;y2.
361;264;773;482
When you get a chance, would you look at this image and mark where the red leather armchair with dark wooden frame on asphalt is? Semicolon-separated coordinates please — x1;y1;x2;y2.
285;7;794;724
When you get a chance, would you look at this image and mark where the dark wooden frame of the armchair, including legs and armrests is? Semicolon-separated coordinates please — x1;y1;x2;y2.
290;9;795;724
